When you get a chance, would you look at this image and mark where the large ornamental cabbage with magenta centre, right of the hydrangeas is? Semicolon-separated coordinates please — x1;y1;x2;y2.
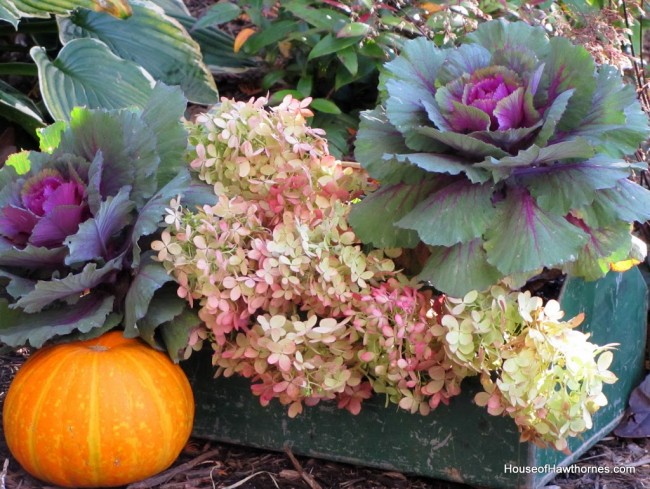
350;20;650;296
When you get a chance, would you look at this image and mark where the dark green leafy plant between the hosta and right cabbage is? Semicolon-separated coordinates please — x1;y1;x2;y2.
196;0;436;156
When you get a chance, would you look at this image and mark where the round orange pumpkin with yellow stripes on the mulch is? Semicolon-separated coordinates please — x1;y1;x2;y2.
3;331;194;487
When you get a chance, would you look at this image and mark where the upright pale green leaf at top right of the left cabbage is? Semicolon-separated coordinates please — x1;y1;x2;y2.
142;83;187;186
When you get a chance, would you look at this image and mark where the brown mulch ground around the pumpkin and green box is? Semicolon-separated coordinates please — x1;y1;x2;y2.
0;350;650;489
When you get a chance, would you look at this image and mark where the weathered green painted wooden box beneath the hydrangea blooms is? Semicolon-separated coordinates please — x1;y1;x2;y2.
185;269;647;489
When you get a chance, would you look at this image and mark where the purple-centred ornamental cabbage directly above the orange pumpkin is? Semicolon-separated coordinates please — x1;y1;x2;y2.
0;85;215;357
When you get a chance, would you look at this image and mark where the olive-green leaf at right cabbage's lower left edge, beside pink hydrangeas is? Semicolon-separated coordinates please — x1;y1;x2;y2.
350;180;436;248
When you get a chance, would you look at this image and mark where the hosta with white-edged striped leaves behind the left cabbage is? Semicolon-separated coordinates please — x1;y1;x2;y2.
0;0;250;152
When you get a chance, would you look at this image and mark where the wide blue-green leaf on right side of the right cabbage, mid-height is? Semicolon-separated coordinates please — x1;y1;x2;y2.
515;157;630;216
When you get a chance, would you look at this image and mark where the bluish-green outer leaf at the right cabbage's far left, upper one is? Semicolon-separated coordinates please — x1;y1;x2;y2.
354;107;425;184
